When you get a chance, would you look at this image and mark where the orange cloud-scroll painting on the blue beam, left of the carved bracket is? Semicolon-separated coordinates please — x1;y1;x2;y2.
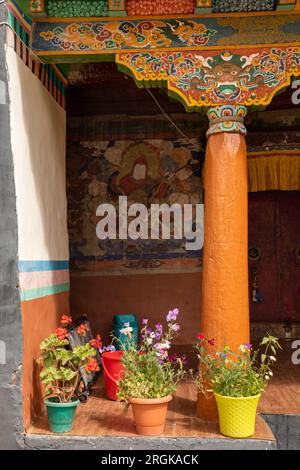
33;20;217;52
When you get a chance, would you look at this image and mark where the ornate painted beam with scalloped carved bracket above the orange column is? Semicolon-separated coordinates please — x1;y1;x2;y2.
27;12;300;111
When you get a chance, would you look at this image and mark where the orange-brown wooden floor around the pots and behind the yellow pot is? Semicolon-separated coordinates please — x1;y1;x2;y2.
27;349;300;440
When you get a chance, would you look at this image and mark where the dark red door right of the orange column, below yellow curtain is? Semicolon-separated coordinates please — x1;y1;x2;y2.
249;191;300;336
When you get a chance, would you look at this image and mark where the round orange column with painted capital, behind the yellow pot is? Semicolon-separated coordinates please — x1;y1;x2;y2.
197;106;249;421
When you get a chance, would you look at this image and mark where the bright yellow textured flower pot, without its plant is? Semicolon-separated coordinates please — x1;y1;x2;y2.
214;393;261;438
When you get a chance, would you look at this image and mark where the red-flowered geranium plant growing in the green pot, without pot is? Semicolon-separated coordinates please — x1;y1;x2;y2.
38;315;101;403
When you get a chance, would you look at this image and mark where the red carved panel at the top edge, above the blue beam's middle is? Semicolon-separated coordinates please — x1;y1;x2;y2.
126;0;194;16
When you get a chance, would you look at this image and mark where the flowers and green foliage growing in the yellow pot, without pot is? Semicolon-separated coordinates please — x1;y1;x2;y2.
194;333;281;398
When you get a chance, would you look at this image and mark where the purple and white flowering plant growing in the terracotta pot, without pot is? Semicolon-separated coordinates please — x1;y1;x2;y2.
118;308;187;404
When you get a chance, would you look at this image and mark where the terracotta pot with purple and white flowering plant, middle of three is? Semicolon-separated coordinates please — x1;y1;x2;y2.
118;308;186;436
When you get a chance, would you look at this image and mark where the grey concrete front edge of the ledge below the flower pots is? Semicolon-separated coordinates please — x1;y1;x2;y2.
24;434;277;451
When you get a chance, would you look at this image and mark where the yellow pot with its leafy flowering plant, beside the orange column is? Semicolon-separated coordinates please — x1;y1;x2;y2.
195;333;281;438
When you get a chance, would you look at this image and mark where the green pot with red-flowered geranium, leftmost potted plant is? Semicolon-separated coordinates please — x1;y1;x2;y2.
38;315;99;433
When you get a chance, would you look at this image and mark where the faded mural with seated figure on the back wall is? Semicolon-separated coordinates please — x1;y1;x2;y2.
67;139;202;274
